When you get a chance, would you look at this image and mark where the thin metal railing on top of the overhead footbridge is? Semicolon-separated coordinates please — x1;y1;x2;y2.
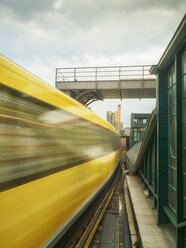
56;65;155;82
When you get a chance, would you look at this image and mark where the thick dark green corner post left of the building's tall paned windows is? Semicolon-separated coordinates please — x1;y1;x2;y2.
157;71;168;224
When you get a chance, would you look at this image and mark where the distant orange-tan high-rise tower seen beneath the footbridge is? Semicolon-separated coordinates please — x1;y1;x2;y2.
107;104;123;131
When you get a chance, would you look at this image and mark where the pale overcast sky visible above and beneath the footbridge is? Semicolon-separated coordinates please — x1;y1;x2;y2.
0;0;186;126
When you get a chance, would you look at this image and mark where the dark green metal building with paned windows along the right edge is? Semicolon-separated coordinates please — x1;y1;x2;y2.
132;15;186;248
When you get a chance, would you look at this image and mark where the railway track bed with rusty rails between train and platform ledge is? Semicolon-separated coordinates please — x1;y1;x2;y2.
55;166;131;248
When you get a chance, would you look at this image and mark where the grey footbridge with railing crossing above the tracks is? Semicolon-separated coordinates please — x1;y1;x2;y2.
56;65;156;106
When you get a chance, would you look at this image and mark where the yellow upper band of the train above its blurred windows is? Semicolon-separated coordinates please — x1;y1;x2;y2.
0;55;119;135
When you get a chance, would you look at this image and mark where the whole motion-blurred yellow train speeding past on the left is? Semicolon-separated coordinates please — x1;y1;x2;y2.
0;56;120;248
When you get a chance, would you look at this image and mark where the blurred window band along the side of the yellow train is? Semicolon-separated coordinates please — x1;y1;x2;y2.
0;85;120;190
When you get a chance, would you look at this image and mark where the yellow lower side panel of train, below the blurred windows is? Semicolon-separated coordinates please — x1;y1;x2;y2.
0;151;120;248
